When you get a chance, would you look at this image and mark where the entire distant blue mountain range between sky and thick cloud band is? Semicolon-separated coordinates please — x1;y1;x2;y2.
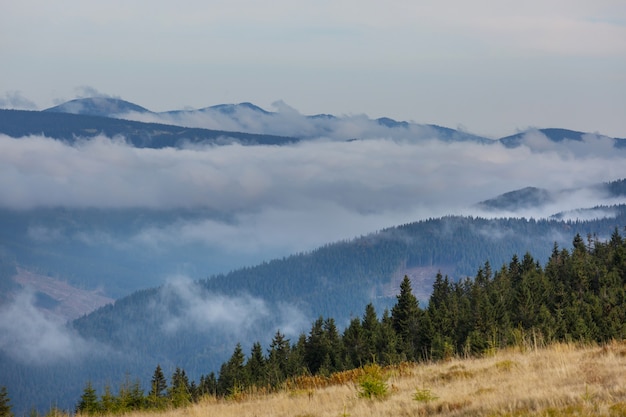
0;97;626;148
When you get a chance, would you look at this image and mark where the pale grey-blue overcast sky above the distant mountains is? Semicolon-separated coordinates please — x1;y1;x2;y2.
0;0;626;137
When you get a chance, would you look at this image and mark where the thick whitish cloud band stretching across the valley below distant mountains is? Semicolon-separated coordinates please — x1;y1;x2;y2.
0;132;626;262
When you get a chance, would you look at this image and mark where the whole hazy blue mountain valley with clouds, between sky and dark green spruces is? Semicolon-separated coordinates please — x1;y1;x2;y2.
0;97;626;407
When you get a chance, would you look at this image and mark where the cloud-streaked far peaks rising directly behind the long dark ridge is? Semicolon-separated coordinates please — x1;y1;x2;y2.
36;98;494;143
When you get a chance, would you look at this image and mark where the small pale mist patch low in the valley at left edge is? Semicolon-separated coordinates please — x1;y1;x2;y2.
0;289;93;365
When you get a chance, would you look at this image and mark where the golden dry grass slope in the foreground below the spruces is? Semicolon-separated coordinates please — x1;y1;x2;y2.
100;342;626;417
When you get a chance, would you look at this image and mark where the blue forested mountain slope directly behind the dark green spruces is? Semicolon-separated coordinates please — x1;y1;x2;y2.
0;205;626;407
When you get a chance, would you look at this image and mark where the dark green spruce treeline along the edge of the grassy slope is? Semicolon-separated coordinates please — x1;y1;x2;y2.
76;229;626;414
